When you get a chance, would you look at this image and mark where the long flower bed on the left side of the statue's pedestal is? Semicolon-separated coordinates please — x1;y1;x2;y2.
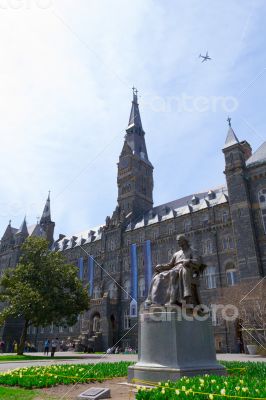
0;362;132;388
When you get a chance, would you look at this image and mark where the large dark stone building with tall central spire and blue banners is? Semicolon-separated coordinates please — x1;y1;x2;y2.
0;91;266;352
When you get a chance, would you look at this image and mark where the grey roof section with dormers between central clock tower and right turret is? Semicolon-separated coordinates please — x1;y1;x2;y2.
126;186;228;231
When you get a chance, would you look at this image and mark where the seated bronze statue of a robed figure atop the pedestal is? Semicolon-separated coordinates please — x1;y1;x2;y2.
145;235;205;306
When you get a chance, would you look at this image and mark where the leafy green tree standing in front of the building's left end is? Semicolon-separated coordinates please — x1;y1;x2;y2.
0;237;89;354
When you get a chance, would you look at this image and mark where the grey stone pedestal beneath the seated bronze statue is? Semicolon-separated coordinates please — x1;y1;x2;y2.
128;310;226;383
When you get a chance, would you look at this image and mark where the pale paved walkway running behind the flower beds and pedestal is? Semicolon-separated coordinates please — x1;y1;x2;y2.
0;352;266;372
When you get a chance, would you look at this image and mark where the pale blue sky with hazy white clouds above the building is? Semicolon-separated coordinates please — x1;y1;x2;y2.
0;0;266;235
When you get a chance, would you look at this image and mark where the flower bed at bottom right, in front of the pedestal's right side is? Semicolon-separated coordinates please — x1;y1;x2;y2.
136;362;266;400
